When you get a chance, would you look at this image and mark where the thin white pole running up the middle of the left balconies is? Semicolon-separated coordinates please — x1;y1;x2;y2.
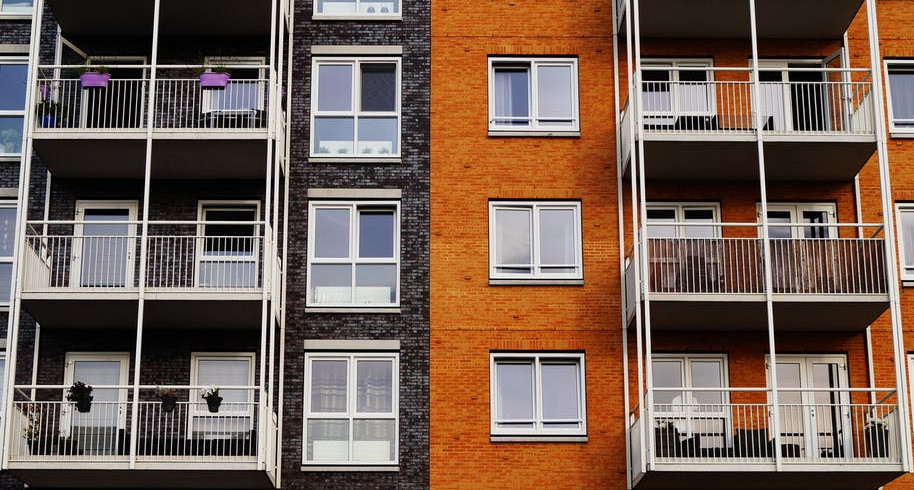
130;0;161;469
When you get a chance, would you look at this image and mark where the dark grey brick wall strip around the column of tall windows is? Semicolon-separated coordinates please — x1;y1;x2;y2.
282;0;430;489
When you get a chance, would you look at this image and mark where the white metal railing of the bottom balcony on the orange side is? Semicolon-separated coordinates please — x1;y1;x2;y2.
648;388;901;465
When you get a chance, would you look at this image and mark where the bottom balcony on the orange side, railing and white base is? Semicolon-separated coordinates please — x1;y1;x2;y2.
630;388;905;490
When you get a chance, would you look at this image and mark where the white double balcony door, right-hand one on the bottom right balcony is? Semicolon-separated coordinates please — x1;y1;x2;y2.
766;355;854;459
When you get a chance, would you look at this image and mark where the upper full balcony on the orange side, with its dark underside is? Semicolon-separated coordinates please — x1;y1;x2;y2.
622;66;876;181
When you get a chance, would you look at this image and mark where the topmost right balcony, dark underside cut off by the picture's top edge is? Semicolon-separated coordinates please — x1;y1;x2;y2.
617;0;863;40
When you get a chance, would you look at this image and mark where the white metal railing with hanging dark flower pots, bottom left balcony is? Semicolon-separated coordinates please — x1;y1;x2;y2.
9;386;261;462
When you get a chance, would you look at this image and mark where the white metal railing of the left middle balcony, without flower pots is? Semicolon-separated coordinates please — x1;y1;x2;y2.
22;221;264;292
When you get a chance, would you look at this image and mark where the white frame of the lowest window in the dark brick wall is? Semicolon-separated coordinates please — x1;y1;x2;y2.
302;351;400;466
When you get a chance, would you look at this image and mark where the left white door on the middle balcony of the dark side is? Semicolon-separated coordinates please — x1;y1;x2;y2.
70;201;137;288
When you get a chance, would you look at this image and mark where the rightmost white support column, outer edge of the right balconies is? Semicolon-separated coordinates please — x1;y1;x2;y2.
866;0;911;471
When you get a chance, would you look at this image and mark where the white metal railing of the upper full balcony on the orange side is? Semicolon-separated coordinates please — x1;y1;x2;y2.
640;66;876;135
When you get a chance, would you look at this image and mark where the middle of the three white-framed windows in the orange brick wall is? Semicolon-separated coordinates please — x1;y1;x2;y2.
489;201;584;279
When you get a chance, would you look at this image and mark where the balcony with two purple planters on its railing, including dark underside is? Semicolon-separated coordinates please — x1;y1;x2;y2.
33;65;272;179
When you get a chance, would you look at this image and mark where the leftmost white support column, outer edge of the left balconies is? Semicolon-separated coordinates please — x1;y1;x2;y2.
0;0;44;469
